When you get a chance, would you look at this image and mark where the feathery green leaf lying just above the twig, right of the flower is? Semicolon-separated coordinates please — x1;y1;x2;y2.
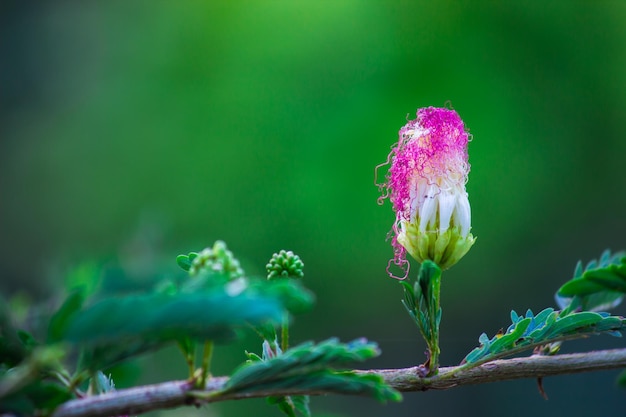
463;308;626;364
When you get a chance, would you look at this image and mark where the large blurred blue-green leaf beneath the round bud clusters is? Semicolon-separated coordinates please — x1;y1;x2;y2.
62;280;312;369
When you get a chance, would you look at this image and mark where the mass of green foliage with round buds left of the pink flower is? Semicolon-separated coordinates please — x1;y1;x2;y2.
0;241;390;417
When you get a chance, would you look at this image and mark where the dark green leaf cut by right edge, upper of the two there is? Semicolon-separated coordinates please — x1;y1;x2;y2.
556;250;626;311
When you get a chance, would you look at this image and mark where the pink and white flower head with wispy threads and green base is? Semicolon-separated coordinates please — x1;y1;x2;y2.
379;107;476;279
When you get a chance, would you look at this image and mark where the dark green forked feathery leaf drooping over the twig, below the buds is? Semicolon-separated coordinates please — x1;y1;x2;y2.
223;339;401;401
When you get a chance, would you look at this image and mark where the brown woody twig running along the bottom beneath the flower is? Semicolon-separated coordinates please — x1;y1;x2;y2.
53;349;626;417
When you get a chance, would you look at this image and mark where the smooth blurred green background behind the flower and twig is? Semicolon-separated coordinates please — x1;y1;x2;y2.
0;0;626;417
